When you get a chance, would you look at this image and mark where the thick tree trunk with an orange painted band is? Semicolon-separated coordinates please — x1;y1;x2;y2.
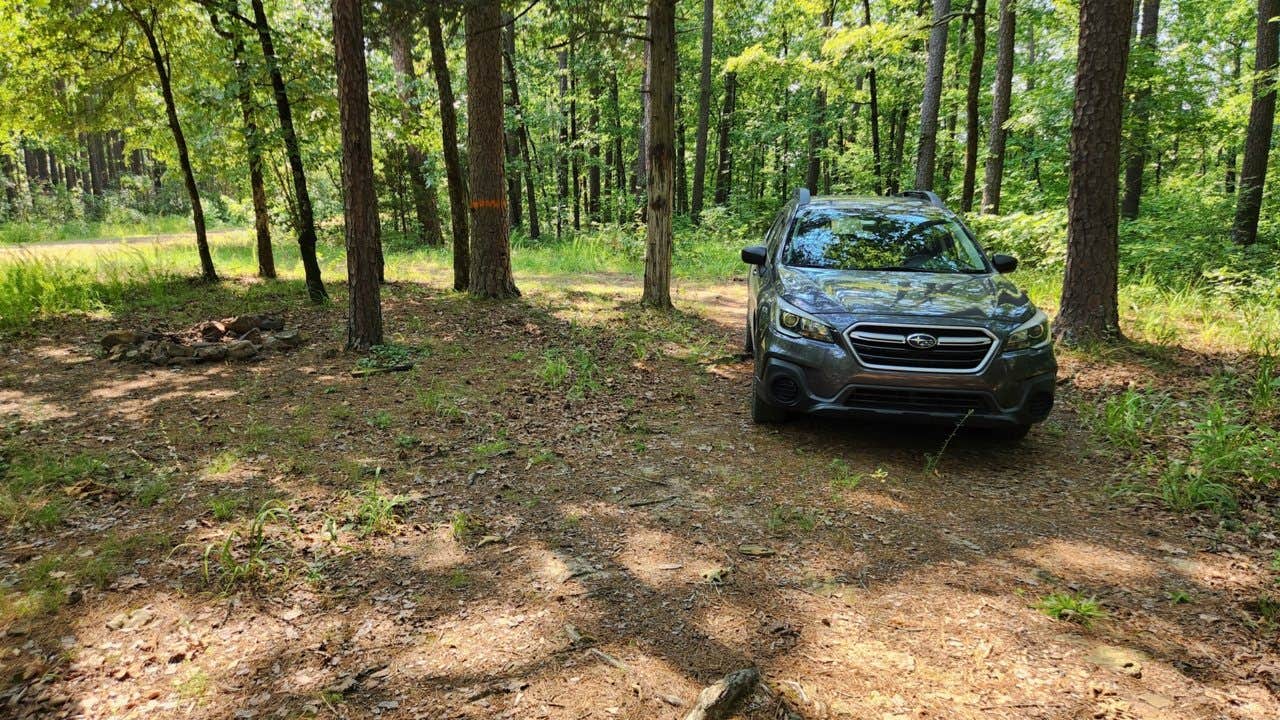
466;0;520;297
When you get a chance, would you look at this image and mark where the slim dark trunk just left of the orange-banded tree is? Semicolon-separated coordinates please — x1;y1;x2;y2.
426;0;473;291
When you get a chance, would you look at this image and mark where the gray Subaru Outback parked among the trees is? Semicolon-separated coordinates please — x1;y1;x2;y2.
742;190;1057;438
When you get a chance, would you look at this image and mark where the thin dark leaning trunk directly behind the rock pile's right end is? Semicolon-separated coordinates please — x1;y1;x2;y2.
252;0;329;302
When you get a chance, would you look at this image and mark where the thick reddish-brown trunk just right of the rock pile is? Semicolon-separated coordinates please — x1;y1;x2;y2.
332;0;383;350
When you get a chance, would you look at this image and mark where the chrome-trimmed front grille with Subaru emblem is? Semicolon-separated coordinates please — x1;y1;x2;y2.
847;323;997;373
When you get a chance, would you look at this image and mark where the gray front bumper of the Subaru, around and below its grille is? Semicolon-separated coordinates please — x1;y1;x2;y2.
754;326;1057;427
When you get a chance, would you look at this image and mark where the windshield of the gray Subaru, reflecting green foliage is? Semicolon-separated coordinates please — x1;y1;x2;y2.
782;208;988;273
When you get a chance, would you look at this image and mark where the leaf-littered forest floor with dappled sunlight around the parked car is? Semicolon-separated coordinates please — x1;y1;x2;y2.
0;270;1280;719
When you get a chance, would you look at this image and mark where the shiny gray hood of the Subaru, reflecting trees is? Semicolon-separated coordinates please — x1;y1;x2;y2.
778;266;1036;322
